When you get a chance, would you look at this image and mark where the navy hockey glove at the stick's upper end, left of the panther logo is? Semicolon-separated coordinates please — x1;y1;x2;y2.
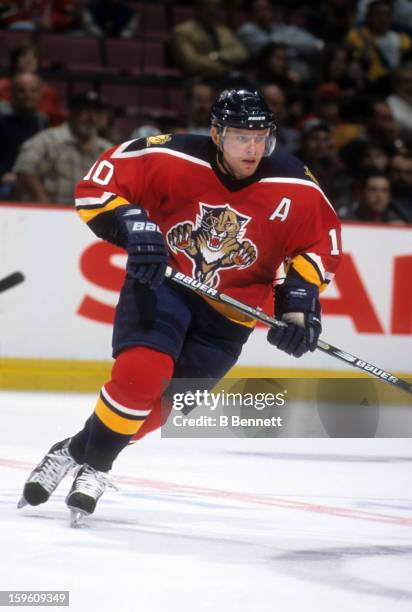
115;204;168;289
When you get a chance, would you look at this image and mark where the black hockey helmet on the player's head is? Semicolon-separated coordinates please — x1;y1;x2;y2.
211;89;276;155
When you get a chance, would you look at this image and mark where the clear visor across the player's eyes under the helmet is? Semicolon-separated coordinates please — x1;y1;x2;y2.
219;127;276;159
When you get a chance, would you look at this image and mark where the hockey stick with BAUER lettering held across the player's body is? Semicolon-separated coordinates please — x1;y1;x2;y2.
166;267;412;394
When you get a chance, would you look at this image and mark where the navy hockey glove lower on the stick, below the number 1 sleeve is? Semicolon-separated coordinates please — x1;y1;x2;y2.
267;277;322;357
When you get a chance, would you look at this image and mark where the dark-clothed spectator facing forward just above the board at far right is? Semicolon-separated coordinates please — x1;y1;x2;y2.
339;170;402;223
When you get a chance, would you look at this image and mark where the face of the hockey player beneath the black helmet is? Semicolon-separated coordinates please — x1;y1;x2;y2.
212;128;268;179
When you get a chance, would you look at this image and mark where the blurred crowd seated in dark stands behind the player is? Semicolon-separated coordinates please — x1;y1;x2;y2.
0;0;412;224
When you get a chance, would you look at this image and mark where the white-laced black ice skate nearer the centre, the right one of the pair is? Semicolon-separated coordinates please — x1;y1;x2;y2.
66;463;113;527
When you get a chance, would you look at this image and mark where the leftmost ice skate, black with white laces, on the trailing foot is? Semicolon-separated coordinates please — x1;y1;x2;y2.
17;438;78;508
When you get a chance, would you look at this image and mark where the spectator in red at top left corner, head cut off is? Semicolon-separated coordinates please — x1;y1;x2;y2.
0;0;74;32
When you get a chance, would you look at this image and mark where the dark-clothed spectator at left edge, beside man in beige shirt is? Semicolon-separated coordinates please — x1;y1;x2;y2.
0;73;48;199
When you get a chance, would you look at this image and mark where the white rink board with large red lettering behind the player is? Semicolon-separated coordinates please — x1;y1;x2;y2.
0;204;412;372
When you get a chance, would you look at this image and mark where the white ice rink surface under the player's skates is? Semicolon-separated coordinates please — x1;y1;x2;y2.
0;392;412;612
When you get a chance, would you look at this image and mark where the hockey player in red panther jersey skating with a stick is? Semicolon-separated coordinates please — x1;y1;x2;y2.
19;90;340;520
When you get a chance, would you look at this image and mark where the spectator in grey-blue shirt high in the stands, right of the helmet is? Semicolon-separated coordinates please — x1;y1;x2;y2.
238;0;324;80
